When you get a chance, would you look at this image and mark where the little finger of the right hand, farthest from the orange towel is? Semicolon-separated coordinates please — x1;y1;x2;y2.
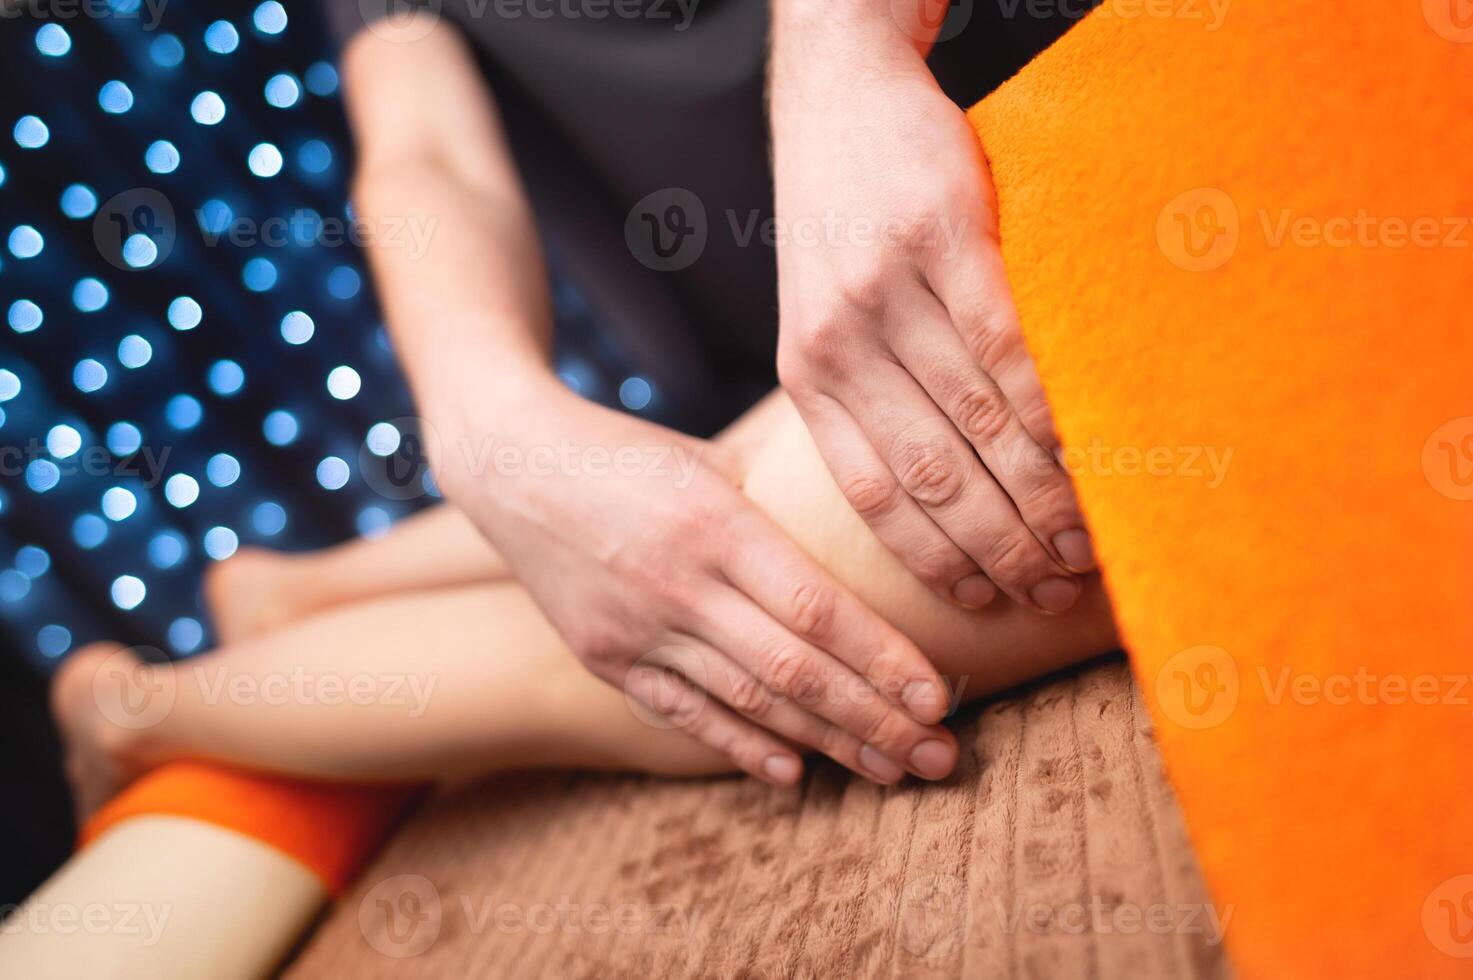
803;393;997;609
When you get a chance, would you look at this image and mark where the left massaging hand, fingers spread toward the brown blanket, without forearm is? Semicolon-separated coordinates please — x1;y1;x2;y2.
436;377;956;784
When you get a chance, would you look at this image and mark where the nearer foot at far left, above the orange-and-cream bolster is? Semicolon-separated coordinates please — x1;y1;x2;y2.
52;643;164;827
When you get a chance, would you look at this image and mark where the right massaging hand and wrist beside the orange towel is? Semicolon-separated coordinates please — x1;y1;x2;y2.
772;0;1094;613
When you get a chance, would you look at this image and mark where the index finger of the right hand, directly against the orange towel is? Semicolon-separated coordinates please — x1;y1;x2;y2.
925;220;1059;451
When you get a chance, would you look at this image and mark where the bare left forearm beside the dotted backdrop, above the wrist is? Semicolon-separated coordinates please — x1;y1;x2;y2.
343;22;552;435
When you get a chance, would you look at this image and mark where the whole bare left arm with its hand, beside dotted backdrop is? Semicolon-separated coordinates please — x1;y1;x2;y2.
343;22;955;778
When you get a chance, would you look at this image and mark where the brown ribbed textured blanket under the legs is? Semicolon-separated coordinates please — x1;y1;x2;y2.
287;657;1231;980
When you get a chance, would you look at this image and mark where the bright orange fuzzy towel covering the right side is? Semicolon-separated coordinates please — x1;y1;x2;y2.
971;0;1473;979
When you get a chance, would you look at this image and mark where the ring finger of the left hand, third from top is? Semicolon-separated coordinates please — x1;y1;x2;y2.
650;638;904;784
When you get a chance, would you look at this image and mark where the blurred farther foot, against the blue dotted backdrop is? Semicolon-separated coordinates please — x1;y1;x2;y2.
205;548;306;644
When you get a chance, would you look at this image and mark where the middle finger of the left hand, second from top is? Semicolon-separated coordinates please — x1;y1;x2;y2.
701;580;956;780
